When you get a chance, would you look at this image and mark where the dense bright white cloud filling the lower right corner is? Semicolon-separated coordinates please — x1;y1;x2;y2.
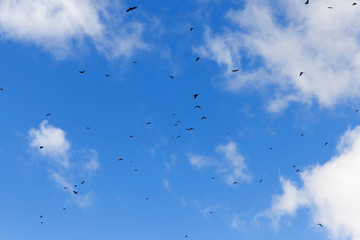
268;126;360;240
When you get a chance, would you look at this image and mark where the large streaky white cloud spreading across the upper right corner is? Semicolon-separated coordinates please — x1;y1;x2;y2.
199;0;360;112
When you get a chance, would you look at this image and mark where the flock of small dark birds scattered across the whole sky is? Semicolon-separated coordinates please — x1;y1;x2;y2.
0;0;359;234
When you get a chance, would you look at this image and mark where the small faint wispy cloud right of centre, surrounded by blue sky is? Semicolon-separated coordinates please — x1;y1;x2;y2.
189;142;251;184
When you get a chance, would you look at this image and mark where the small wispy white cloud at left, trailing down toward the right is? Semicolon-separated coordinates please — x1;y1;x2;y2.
28;120;100;207
